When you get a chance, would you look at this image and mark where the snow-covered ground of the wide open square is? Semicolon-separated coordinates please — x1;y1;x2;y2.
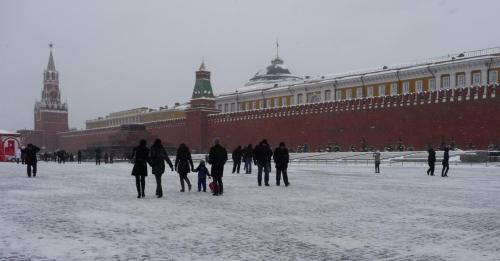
0;162;500;260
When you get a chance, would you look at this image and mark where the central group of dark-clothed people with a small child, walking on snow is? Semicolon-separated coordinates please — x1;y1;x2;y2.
132;139;290;198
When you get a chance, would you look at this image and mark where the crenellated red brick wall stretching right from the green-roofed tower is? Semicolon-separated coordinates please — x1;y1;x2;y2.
206;86;500;150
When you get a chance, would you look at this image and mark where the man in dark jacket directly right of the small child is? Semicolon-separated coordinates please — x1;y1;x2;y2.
208;138;227;196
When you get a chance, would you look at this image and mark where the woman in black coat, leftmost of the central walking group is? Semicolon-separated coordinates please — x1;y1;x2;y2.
132;140;149;198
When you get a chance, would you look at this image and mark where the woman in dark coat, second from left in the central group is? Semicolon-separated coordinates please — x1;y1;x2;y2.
149;139;174;198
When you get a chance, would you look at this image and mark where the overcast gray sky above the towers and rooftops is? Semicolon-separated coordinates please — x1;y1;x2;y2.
0;0;500;130
